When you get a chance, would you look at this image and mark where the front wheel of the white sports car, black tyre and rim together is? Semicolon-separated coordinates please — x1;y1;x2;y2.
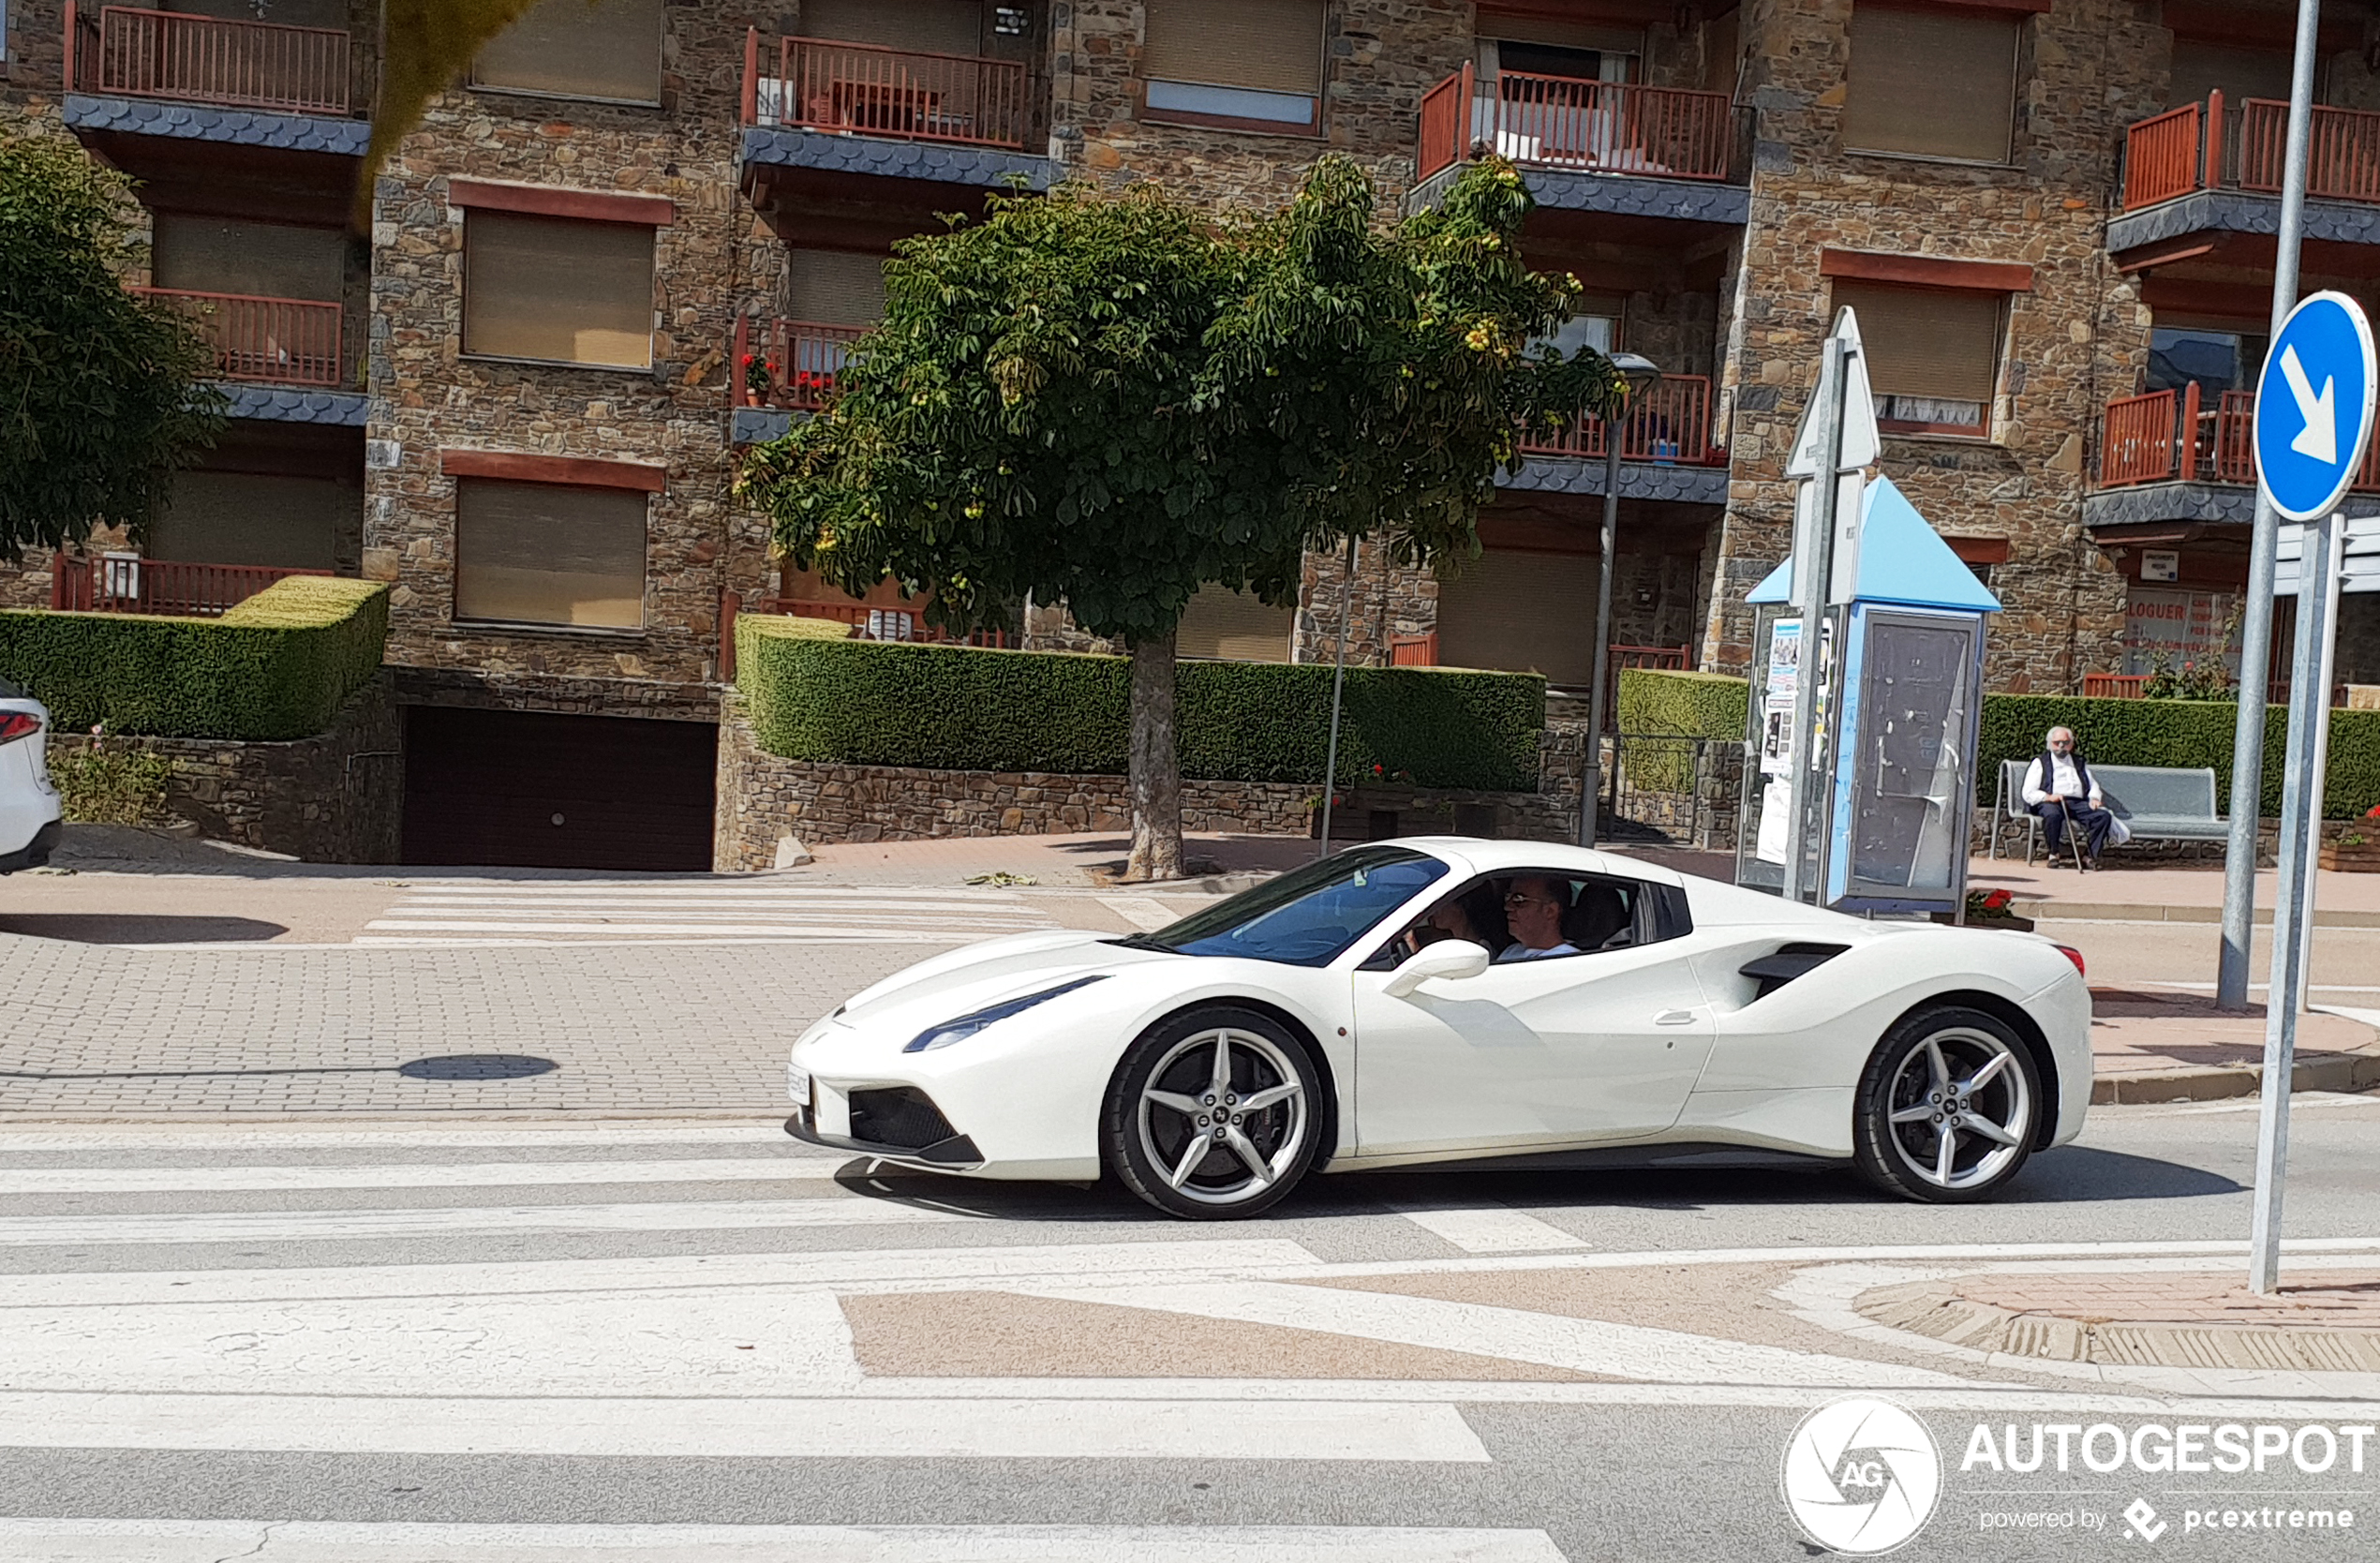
1099;1004;1328;1220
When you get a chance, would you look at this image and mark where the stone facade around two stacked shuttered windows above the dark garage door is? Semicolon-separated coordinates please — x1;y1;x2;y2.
364;5;793;708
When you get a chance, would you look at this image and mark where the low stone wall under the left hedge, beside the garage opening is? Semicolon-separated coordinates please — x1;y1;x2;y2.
50;676;405;864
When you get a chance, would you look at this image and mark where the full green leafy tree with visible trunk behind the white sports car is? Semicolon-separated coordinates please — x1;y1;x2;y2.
740;157;1616;878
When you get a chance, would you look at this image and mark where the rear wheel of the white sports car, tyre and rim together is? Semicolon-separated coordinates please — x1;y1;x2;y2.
1852;1004;2045;1204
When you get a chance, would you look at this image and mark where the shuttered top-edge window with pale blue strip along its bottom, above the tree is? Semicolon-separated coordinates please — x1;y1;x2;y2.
1140;0;1323;136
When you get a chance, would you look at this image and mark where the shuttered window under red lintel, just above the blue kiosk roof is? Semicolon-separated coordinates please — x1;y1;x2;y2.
1833;278;2009;436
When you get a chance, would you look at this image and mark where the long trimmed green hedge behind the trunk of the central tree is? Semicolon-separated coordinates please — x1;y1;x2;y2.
736;614;1544;790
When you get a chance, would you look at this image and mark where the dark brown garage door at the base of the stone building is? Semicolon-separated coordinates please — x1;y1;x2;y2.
405;707;719;871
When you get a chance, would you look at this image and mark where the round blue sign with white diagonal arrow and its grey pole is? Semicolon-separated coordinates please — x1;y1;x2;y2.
2230;292;2375;1294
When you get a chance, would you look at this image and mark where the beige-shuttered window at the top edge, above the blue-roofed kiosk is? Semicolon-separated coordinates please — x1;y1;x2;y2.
1842;0;2020;162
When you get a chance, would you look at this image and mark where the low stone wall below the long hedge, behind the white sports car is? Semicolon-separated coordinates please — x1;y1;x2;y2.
711;694;1581;873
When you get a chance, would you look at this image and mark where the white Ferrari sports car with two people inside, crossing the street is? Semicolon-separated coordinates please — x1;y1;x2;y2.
785;838;2092;1218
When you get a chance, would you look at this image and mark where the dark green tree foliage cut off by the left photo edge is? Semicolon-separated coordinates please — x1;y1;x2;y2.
0;133;221;561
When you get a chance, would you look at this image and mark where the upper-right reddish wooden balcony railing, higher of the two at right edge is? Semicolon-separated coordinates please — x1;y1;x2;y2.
2123;93;2380;212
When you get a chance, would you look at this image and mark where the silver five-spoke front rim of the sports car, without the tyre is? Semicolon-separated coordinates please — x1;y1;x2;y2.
1136;1025;1314;1206
